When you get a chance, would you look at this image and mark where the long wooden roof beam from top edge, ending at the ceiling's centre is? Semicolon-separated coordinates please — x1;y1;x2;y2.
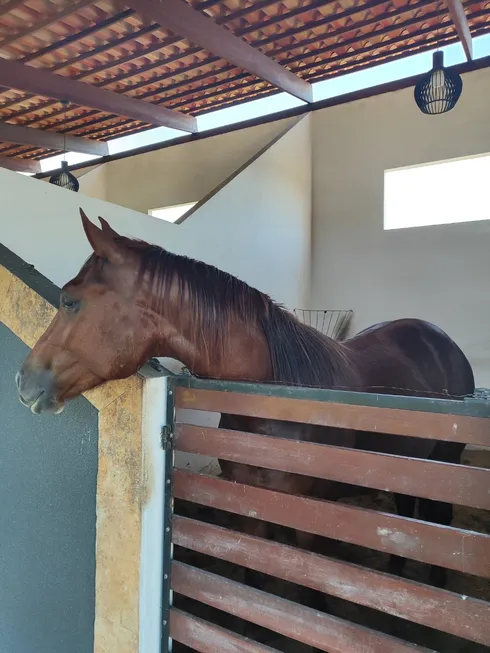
124;0;313;102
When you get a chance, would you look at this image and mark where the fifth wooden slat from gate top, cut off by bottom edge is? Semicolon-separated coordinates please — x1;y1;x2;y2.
172;562;436;653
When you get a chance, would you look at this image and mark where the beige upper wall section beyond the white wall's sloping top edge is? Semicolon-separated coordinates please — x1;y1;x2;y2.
80;114;292;213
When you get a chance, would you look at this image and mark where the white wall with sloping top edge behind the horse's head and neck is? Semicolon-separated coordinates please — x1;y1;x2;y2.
0;118;311;314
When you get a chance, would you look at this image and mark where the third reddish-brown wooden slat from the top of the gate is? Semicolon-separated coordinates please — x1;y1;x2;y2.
174;469;490;578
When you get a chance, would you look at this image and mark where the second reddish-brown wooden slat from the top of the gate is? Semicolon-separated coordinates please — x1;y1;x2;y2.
175;424;490;510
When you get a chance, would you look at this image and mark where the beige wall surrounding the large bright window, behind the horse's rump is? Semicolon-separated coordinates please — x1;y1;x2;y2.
310;69;490;385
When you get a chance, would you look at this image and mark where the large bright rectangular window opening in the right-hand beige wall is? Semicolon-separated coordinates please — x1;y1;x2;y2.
384;154;490;229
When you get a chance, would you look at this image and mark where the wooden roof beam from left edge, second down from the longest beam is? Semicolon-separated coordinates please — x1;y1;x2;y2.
0;58;197;132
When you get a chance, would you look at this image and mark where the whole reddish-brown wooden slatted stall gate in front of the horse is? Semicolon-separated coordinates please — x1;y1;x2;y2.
162;376;490;653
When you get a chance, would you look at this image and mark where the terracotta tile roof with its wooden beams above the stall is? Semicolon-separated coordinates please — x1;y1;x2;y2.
0;0;490;171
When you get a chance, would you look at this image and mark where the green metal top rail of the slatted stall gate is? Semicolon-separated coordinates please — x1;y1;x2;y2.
173;374;490;417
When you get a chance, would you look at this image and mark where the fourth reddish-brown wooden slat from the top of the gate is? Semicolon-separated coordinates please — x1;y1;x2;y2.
172;516;490;646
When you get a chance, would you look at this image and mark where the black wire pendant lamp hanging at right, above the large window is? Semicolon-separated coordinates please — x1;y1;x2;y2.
414;52;463;115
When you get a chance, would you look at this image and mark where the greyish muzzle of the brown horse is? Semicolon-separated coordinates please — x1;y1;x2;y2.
15;366;64;415
